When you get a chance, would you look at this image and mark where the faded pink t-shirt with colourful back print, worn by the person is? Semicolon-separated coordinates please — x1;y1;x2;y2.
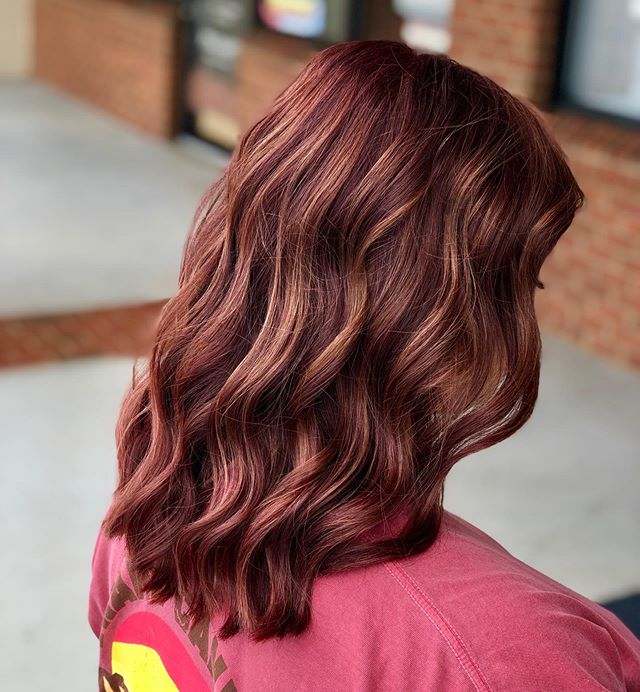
89;512;640;692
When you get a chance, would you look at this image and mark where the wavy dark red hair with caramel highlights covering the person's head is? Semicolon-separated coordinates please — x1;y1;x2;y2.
105;41;582;640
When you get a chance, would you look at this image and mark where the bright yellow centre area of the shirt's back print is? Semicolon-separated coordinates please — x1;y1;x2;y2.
111;642;179;692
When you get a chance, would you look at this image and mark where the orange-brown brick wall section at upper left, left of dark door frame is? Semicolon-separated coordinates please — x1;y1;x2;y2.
35;0;180;137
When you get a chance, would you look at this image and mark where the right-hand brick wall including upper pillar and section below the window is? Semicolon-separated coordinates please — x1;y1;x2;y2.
451;0;640;368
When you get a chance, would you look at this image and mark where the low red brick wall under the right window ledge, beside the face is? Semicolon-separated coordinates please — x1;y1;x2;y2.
537;113;640;368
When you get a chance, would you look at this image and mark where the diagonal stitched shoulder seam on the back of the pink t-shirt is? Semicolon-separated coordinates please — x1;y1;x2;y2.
385;560;491;692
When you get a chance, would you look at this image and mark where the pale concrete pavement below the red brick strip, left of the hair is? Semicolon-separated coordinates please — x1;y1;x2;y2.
0;359;131;692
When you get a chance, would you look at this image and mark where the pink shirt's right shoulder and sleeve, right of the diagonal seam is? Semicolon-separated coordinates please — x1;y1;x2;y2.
387;513;640;691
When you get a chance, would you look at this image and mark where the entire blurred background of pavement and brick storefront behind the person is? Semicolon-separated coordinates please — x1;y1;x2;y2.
0;0;640;691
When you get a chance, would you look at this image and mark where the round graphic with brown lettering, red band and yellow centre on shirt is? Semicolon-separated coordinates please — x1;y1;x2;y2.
98;576;236;692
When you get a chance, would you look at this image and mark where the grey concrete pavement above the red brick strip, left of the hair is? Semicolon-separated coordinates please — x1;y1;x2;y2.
0;80;228;317
